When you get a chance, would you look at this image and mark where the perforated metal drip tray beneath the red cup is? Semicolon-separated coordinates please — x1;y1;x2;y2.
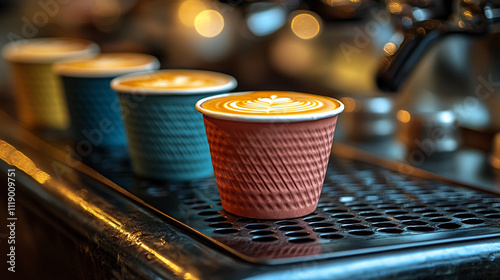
87;147;500;264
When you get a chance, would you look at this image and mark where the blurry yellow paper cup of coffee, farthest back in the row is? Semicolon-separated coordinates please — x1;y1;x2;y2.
2;38;99;130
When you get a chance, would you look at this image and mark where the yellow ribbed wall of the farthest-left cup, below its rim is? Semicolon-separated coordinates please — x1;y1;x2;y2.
10;62;69;130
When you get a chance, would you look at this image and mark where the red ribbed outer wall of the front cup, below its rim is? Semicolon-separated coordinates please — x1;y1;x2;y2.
204;116;338;219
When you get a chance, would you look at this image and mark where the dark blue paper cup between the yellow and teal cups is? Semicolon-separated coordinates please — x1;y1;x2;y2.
54;53;160;148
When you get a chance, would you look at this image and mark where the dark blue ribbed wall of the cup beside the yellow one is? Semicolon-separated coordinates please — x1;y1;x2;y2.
62;77;127;148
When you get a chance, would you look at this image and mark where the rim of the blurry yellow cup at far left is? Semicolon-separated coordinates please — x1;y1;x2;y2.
2;37;100;63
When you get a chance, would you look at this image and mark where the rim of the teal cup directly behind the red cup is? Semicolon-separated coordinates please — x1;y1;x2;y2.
111;69;238;95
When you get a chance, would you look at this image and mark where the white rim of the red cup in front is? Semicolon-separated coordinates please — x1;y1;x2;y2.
195;91;344;122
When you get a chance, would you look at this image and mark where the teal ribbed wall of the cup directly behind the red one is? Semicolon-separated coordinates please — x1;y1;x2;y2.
119;93;213;180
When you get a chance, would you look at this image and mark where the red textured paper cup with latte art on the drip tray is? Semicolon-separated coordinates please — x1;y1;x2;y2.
196;91;344;219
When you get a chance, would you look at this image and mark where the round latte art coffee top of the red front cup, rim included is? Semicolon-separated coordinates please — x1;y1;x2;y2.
197;91;344;120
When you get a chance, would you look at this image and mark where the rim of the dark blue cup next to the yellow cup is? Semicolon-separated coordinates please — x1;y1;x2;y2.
53;52;160;78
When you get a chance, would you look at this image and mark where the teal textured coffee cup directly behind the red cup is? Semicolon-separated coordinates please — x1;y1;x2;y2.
111;70;237;180
